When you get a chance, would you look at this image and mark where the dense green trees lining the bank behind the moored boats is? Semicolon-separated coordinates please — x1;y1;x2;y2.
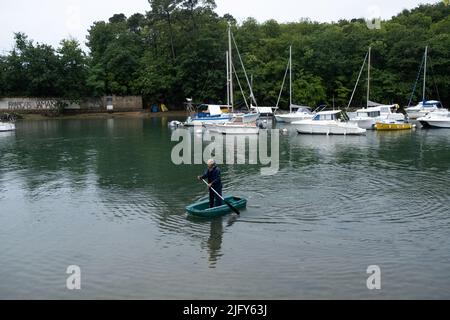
0;0;450;108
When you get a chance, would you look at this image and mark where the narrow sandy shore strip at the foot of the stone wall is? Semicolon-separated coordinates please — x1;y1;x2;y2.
19;111;186;121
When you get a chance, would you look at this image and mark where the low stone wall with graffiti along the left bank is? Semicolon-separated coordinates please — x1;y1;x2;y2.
0;96;143;113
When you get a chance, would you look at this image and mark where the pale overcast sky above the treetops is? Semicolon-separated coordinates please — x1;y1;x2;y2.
0;0;439;53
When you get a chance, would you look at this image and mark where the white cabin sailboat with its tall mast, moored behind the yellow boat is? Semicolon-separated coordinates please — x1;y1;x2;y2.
347;47;405;130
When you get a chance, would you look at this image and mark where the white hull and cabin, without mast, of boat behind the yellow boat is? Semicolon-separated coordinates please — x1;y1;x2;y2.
349;105;405;130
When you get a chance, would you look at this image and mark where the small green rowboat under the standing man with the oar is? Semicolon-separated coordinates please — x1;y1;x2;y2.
186;196;247;218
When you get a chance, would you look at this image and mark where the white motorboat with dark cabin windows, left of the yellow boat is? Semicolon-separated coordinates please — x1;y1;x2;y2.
292;110;366;135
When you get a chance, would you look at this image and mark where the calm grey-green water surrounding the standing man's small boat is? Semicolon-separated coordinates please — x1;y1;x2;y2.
0;119;450;299
